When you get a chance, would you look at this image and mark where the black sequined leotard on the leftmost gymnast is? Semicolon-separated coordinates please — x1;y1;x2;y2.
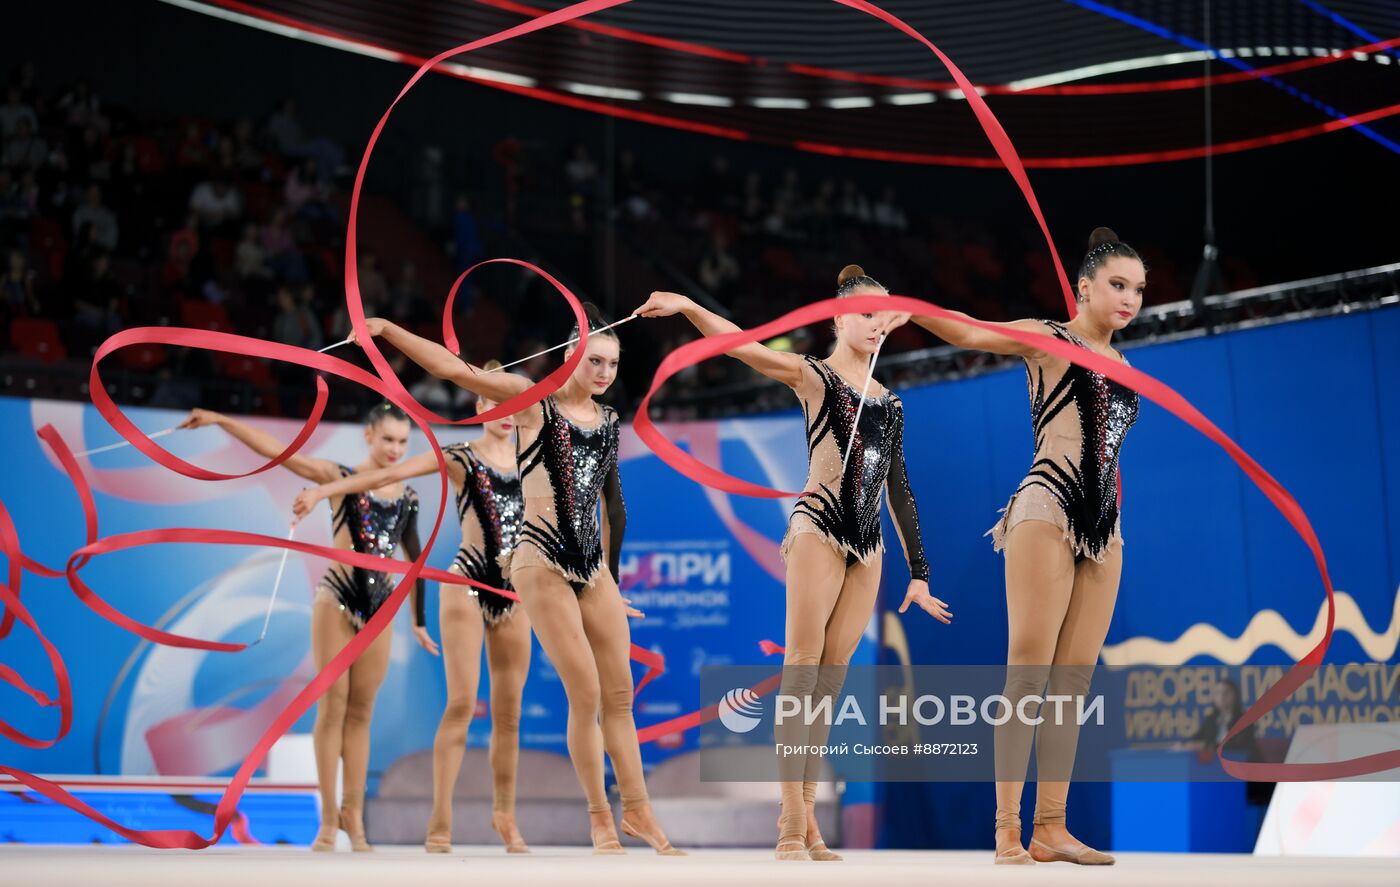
321;464;423;628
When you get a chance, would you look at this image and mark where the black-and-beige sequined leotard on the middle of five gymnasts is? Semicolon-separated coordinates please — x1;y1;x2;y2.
505;397;627;593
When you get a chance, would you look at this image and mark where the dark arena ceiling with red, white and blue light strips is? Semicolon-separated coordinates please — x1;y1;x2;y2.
165;0;1400;168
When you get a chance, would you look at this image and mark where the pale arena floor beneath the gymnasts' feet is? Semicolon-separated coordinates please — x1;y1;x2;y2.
0;845;1397;887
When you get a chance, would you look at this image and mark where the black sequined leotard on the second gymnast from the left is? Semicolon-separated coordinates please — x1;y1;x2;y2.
414;444;525;625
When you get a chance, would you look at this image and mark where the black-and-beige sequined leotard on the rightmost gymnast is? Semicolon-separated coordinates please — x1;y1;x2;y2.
987;320;1138;562
